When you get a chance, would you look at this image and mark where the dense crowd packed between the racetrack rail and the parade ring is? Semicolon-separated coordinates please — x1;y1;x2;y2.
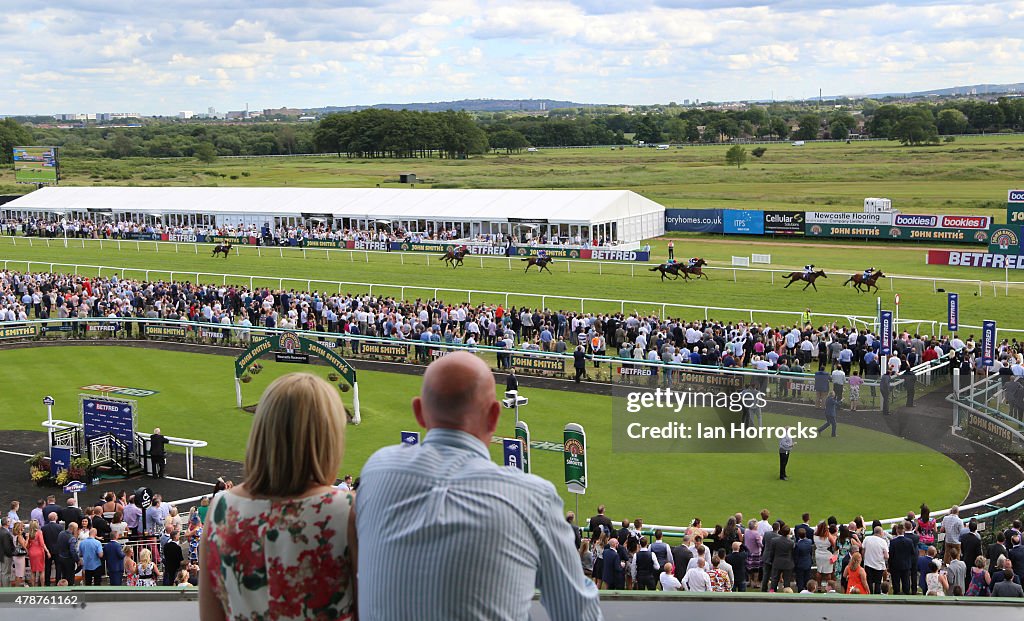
0;271;1024;385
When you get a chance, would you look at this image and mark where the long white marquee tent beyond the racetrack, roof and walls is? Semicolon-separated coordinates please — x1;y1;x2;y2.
0;187;665;243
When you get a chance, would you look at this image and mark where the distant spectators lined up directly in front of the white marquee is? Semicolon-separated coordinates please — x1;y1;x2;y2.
0;218;612;248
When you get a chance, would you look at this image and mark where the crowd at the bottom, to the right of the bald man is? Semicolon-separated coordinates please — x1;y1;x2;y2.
566;504;1024;597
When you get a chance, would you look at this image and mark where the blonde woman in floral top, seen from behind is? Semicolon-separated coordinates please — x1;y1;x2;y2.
200;373;356;621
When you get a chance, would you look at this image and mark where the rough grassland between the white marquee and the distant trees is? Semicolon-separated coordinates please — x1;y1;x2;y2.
0;135;1024;216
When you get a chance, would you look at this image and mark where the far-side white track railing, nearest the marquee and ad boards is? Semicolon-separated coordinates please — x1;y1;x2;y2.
0;236;999;296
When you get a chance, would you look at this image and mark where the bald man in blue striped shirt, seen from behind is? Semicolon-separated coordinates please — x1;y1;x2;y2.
355;351;601;621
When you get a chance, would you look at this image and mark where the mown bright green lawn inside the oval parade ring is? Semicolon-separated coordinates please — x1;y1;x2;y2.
0;346;970;525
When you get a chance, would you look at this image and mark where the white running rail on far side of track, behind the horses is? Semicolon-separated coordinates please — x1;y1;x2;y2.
0;236;1007;296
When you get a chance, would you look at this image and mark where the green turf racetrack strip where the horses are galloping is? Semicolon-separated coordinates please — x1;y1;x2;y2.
0;238;1024;335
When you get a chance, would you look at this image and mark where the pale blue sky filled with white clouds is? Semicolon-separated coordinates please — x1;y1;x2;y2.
0;0;1024;115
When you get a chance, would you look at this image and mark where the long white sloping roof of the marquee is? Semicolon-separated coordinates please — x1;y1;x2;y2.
3;187;665;223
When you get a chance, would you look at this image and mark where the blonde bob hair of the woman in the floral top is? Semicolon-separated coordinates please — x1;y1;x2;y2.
245;373;345;497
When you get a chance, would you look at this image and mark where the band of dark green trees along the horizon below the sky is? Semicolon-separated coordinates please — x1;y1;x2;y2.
6;97;1024;164
